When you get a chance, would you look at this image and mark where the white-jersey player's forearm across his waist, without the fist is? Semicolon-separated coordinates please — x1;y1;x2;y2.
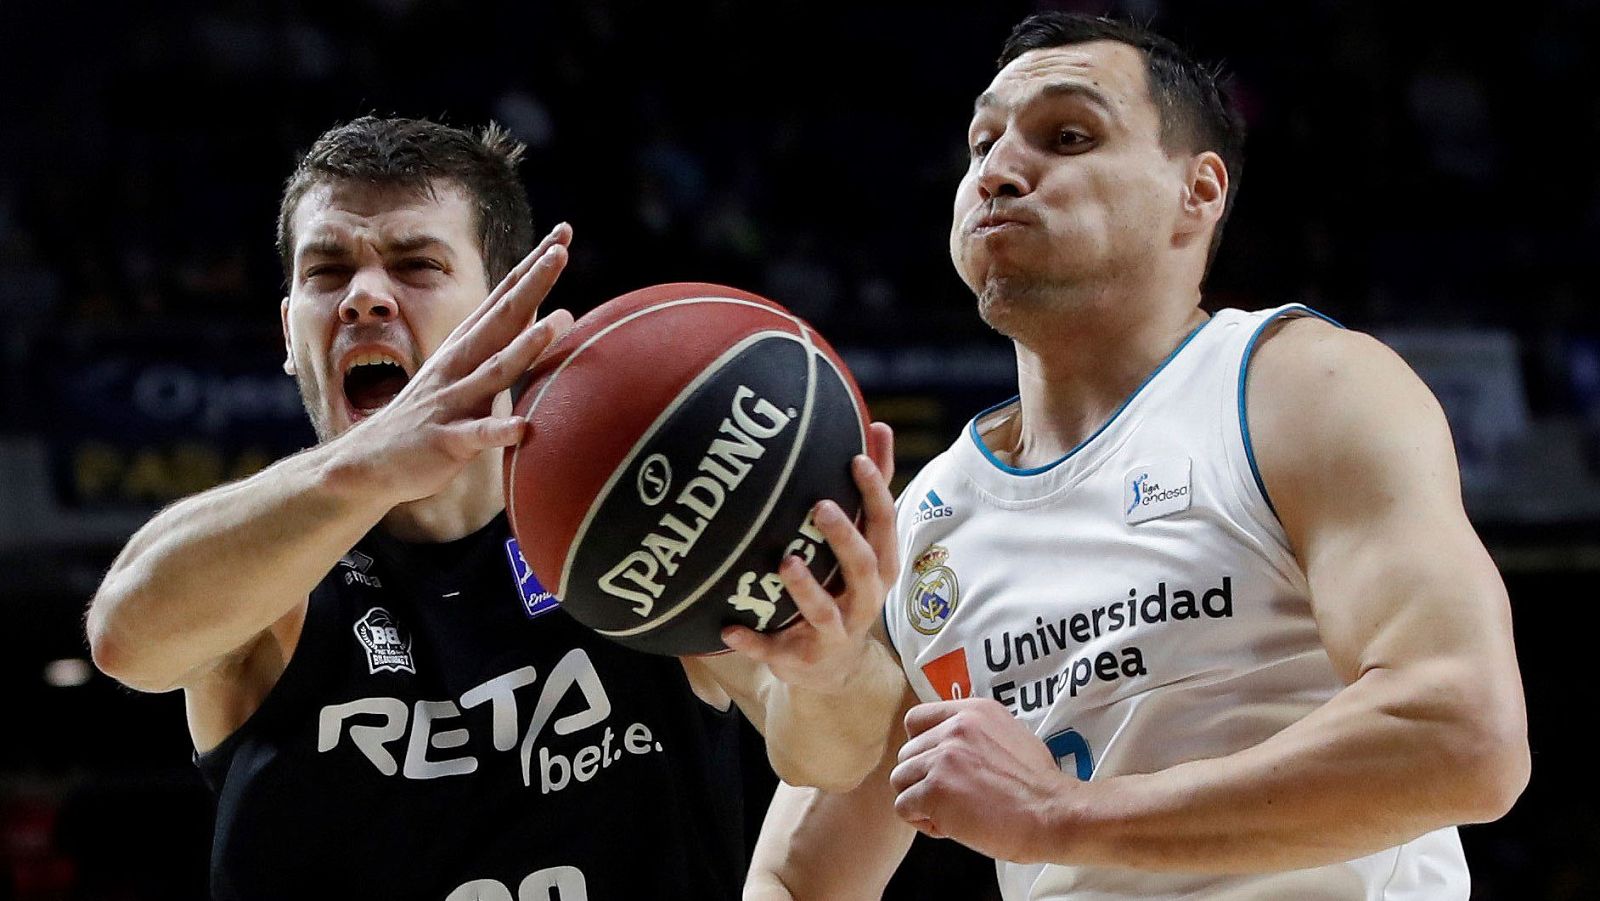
1040;661;1528;872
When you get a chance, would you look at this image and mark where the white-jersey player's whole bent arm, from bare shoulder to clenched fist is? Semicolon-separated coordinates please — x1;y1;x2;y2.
891;320;1530;872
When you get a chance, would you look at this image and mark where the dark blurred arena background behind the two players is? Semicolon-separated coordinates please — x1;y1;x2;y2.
0;0;1600;901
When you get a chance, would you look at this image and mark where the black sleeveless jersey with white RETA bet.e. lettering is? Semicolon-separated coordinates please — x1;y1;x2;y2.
198;515;746;901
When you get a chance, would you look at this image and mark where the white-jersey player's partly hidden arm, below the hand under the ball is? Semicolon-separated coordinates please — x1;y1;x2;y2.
744;690;917;901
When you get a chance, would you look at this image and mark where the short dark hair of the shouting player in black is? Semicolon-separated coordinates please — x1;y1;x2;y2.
278;115;533;285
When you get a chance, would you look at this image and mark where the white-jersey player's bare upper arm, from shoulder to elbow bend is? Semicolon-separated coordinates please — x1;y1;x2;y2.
1246;320;1515;682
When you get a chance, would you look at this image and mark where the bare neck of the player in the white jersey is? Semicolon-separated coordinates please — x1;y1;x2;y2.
990;296;1208;469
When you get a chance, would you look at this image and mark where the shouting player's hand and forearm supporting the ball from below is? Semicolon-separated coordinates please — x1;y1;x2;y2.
685;422;906;791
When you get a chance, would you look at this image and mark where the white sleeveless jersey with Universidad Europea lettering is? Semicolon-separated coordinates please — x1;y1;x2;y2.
885;306;1469;901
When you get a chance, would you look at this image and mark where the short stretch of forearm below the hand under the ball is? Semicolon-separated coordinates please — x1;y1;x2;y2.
762;642;907;792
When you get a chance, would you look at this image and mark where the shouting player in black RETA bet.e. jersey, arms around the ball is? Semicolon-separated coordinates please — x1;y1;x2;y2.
88;118;902;901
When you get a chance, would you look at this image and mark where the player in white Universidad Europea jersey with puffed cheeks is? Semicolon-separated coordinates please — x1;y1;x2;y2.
746;14;1528;901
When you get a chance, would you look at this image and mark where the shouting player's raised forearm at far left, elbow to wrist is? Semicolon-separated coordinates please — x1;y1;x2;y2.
86;443;389;691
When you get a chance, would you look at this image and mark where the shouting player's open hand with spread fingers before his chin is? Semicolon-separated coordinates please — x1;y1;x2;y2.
338;222;573;506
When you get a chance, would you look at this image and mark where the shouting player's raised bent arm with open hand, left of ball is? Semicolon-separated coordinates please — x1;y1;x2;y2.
86;226;571;691
